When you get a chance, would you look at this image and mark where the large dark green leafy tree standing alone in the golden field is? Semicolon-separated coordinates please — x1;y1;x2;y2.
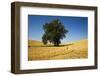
42;19;68;46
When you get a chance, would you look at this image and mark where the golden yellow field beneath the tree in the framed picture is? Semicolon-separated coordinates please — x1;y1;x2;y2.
28;40;88;60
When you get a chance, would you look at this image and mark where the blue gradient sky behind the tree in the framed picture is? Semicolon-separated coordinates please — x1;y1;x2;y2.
28;15;88;43
